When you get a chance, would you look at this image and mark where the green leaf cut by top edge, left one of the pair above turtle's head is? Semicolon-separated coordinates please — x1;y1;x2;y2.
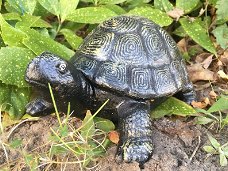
37;0;60;16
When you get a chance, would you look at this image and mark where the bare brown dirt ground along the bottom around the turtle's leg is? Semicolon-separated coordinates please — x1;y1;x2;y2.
0;113;228;171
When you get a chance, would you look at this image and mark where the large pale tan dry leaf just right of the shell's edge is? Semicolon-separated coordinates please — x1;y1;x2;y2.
188;63;214;82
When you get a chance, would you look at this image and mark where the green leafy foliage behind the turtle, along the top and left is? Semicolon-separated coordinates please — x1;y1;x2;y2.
0;0;228;118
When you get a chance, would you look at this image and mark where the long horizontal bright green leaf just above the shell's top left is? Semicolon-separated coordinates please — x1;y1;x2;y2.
66;7;117;24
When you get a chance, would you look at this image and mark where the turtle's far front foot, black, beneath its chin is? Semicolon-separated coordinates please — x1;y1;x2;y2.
26;98;54;116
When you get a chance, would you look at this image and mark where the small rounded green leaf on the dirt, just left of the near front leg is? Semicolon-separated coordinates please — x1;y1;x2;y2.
94;117;115;132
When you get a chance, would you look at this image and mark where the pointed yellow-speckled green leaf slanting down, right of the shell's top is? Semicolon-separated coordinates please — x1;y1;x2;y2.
179;18;216;54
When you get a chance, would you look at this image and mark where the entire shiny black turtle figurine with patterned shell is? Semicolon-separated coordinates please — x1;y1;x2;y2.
25;16;195;166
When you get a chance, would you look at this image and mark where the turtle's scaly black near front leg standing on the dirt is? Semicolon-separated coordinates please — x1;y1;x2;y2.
117;100;153;166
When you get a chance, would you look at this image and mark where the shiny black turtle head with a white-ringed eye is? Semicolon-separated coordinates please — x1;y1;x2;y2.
25;52;80;96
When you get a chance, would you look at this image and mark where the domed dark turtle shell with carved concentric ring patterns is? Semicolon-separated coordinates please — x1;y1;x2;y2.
71;16;189;99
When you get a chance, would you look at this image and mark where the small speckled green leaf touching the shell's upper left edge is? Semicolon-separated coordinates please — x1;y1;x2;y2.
60;29;83;49
